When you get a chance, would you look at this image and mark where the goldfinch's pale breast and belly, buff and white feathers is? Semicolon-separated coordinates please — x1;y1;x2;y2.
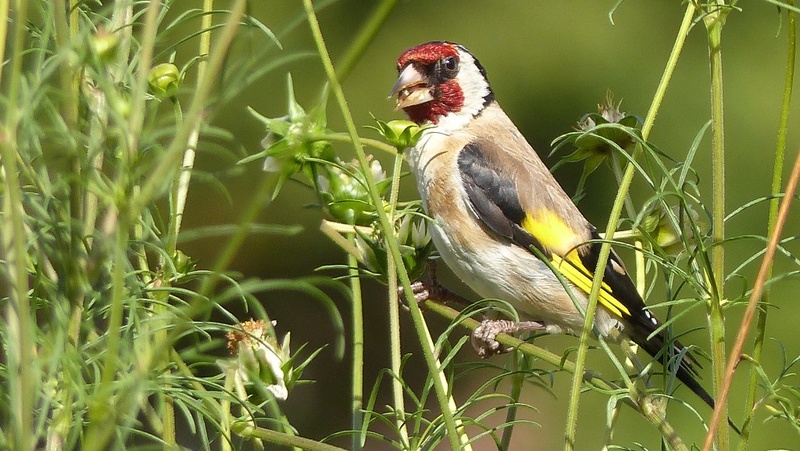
411;135;583;330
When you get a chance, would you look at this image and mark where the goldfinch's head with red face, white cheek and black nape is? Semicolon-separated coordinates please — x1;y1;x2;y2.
392;41;494;129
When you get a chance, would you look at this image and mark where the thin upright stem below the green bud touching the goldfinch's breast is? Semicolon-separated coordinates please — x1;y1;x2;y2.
386;152;410;447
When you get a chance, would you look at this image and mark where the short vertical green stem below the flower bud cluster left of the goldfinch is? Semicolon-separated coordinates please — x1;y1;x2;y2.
347;237;364;451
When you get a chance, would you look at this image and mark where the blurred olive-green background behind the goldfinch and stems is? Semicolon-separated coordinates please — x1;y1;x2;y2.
176;0;800;449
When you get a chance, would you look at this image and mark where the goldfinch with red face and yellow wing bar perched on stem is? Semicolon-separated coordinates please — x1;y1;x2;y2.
390;41;737;429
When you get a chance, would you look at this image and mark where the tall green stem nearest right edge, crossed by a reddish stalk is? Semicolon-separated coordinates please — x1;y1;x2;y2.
739;0;797;451
